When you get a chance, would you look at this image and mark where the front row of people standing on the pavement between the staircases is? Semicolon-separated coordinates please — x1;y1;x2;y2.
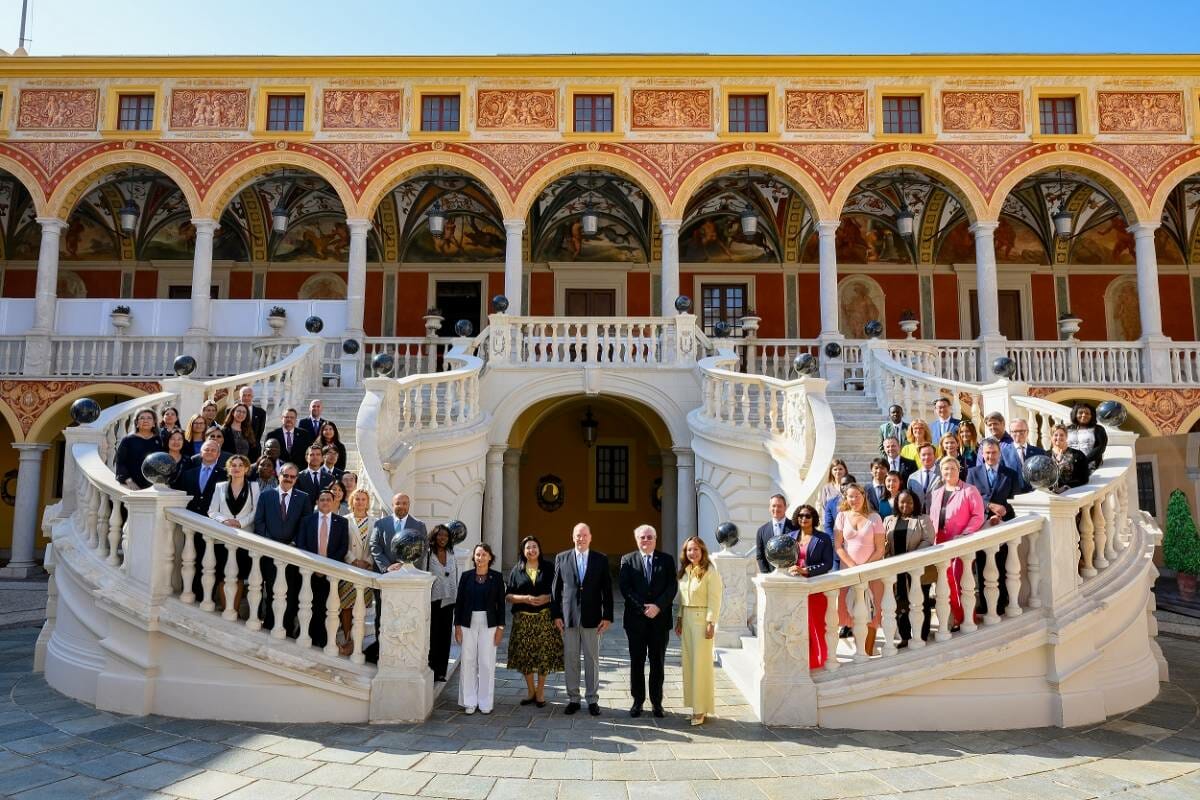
441;522;721;724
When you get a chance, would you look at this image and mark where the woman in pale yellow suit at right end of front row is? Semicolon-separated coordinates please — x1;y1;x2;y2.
676;536;721;724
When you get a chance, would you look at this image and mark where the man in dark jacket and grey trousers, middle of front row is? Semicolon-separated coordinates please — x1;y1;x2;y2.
550;522;612;717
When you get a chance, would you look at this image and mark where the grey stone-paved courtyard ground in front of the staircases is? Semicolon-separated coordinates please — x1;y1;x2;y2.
0;627;1200;800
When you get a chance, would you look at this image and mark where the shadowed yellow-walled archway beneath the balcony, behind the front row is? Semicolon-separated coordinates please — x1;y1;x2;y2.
504;396;676;565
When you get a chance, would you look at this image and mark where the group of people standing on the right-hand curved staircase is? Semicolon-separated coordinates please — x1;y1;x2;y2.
756;397;1108;667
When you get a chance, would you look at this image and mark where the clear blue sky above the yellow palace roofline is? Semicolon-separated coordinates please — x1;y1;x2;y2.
0;0;1200;55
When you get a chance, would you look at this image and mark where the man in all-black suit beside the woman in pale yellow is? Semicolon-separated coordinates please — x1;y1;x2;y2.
617;525;679;717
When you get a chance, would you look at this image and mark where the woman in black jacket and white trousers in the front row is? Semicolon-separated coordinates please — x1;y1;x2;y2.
454;545;504;714
